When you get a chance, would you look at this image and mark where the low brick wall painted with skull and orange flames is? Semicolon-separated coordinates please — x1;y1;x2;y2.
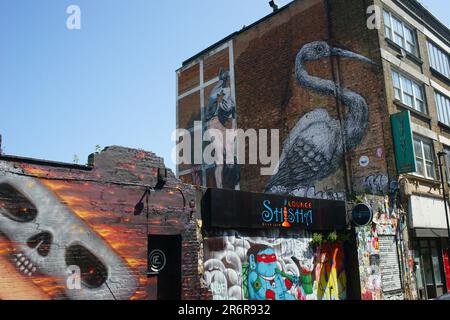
0;147;198;300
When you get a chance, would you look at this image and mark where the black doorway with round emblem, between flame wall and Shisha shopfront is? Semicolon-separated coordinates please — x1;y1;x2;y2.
147;235;181;300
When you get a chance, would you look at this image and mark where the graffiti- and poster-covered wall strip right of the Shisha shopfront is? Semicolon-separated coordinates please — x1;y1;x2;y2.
356;197;416;300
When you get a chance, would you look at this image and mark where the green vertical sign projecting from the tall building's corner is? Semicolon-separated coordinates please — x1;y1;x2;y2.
391;110;417;174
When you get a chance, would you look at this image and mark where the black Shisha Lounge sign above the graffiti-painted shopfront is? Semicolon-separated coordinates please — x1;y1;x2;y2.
202;189;347;231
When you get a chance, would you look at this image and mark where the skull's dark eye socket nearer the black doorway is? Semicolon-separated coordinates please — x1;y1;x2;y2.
66;245;108;288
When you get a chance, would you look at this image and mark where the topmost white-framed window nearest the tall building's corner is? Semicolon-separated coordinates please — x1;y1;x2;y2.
384;10;418;56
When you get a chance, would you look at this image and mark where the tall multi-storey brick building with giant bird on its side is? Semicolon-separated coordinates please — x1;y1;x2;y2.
177;0;450;300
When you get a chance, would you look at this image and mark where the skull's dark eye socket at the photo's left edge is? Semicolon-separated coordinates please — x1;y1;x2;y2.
0;183;38;223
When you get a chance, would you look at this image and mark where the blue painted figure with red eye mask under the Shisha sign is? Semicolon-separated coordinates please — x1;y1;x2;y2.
247;245;298;300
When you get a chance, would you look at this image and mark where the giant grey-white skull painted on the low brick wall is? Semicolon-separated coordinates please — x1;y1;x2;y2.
0;176;137;300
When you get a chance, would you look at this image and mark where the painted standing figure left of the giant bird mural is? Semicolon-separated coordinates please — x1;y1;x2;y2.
204;69;239;189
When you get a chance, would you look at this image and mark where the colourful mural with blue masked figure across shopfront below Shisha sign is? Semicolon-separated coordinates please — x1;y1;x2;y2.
203;233;347;300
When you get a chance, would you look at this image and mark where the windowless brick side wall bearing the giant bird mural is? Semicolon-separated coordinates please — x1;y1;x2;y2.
177;0;389;200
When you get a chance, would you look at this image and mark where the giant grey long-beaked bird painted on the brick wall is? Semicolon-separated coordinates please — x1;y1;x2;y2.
266;41;373;193
